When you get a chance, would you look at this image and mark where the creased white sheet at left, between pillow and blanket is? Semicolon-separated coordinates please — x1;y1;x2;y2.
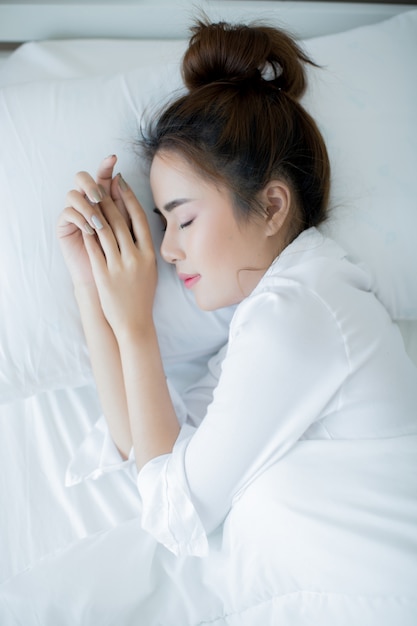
0;387;139;584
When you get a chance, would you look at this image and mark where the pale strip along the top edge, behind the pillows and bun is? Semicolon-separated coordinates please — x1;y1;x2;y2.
0;0;410;42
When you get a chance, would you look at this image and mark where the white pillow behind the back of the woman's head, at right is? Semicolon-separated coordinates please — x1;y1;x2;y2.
305;10;417;320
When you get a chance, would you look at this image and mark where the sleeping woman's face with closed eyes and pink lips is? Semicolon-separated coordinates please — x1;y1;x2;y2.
150;152;275;311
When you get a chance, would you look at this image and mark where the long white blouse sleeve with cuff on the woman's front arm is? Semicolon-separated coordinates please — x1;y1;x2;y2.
138;286;349;556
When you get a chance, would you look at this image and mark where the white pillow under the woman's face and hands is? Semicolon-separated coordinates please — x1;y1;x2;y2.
0;59;232;401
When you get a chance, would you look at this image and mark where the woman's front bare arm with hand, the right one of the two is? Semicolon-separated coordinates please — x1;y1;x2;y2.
78;171;179;469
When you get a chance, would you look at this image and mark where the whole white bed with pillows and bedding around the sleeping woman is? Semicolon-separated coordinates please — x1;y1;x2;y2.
0;0;417;626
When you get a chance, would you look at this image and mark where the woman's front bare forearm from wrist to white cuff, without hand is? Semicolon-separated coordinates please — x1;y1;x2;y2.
118;324;180;470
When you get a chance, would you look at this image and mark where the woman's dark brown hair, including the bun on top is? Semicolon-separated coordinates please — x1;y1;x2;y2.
142;21;330;236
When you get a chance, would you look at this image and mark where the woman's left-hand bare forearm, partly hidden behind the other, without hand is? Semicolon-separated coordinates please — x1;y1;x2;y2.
75;285;132;458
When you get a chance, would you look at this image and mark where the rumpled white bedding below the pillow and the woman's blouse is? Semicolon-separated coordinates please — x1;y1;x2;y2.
0;387;417;626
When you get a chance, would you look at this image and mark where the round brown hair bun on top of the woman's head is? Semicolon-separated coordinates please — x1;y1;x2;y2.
182;21;310;98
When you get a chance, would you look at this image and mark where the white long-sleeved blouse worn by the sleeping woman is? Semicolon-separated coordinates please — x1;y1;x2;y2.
67;228;417;556
